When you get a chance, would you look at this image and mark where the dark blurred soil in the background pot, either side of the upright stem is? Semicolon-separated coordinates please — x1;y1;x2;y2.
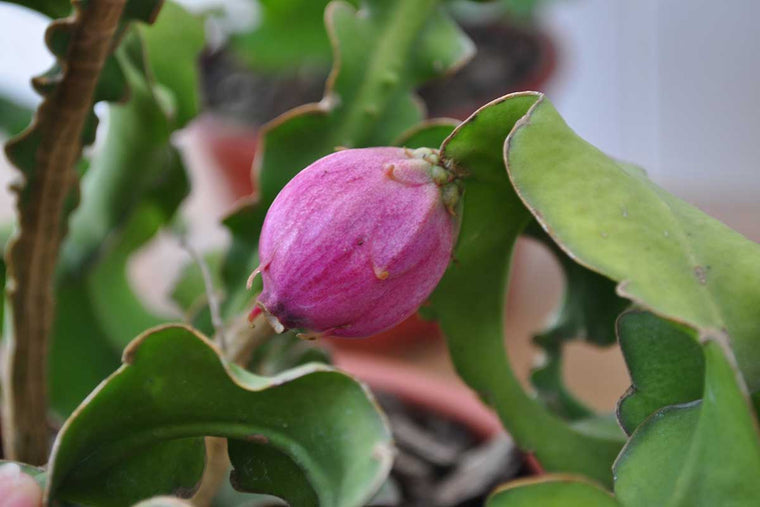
201;21;553;125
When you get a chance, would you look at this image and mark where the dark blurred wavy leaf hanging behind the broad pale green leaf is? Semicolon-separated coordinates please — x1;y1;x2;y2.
526;226;628;419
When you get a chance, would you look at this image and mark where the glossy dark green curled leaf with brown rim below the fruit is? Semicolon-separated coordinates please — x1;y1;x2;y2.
46;325;392;506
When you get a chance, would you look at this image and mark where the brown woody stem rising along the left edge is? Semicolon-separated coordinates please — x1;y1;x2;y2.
3;0;126;465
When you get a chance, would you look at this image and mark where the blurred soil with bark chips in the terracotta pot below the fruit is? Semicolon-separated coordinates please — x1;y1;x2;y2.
369;393;531;507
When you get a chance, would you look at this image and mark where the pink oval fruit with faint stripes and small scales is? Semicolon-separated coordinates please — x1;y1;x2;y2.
254;148;459;337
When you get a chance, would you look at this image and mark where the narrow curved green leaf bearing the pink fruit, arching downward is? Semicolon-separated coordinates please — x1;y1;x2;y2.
432;92;623;484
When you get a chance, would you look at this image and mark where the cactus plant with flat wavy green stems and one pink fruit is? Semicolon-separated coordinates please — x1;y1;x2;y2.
0;0;760;507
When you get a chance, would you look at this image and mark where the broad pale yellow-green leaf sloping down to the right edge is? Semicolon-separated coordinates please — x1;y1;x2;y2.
506;100;760;391
